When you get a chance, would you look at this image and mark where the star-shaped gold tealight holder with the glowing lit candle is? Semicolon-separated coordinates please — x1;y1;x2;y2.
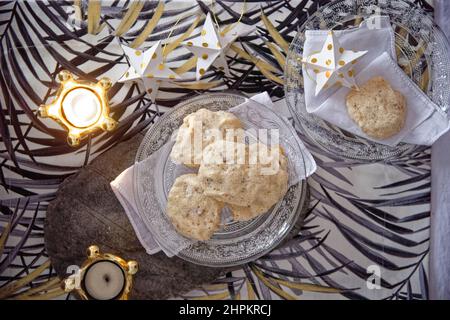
39;70;117;147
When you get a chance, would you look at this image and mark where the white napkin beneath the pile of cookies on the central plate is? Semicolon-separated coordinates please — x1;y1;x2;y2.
111;92;316;257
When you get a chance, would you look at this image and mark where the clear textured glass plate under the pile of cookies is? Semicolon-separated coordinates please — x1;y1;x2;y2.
134;93;306;267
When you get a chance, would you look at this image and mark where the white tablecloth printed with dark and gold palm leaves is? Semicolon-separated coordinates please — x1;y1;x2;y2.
0;0;438;299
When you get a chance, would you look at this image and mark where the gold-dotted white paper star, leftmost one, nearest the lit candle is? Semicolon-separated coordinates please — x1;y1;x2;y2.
119;41;180;101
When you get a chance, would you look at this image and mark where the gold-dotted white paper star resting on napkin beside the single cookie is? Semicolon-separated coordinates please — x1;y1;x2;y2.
302;31;367;95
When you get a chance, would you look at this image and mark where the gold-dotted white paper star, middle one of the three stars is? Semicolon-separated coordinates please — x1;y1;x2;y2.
182;13;255;80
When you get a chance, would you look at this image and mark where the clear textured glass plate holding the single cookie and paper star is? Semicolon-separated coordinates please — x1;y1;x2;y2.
285;0;450;161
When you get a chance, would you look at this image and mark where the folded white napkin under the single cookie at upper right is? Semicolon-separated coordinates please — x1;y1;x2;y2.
303;17;450;146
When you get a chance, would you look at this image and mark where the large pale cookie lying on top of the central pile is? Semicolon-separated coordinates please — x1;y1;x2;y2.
199;141;288;221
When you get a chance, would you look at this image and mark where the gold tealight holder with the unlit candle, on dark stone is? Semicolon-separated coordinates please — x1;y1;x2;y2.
62;245;138;300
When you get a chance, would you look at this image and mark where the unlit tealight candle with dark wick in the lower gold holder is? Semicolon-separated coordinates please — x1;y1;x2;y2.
83;260;125;300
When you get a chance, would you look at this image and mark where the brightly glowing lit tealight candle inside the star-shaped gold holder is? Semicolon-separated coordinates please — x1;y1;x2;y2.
62;88;102;128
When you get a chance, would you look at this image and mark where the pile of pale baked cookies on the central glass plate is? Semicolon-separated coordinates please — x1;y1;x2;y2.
167;109;288;240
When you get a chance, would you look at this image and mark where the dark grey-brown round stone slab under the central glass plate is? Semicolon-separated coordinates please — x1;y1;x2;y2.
44;134;309;299
